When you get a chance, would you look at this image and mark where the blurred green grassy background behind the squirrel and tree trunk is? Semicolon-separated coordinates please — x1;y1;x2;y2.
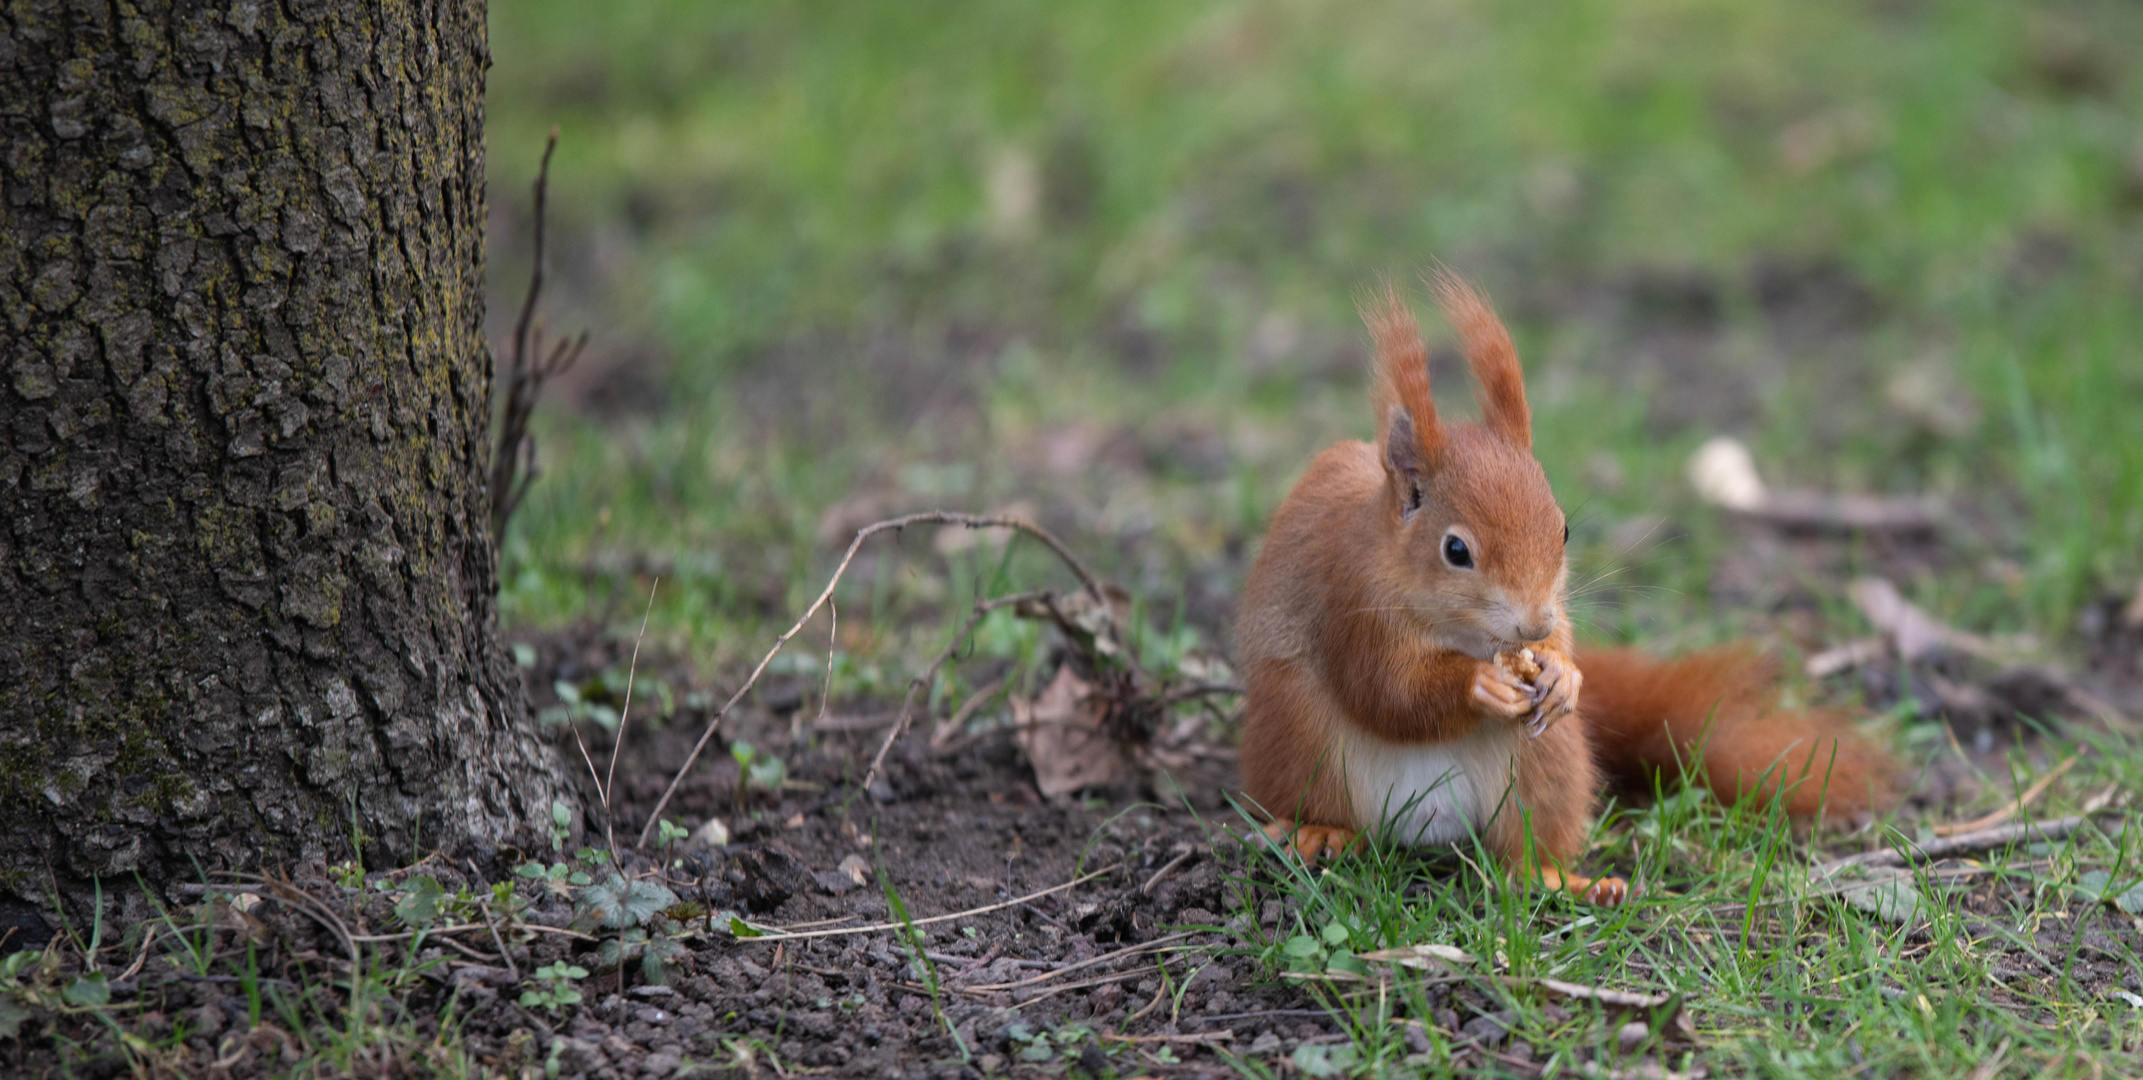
489;0;2143;677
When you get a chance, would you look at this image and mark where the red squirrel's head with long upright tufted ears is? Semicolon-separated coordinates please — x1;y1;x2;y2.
1363;272;1569;660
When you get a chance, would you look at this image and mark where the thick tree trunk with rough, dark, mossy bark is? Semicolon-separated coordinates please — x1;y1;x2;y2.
0;0;570;919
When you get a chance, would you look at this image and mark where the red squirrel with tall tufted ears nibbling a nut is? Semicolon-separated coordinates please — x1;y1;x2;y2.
1237;272;1888;904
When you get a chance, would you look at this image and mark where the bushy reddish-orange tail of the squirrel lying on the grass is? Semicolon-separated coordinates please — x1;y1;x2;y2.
1577;647;1892;816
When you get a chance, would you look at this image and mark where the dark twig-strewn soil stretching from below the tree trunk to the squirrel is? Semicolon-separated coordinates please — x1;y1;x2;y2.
0;641;1344;1078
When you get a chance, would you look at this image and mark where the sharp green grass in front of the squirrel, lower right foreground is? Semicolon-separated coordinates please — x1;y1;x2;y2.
1239;728;2143;1078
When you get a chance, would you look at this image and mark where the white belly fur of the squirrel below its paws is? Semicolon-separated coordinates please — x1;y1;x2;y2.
1339;722;1524;844
